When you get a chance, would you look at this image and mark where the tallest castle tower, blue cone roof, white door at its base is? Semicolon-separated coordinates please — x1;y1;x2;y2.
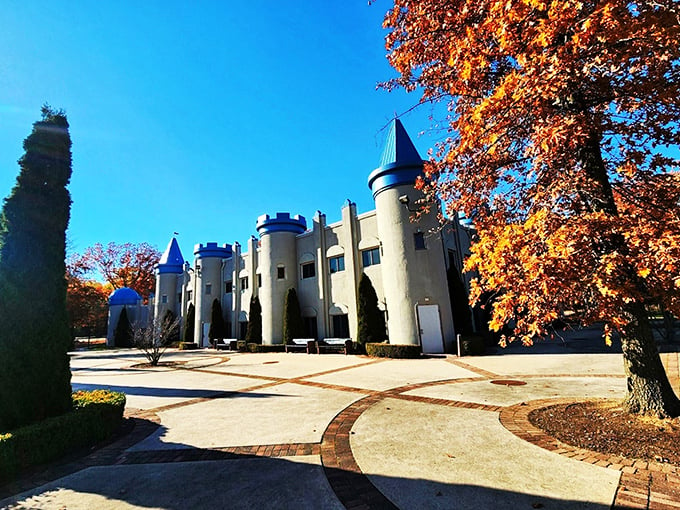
368;119;455;353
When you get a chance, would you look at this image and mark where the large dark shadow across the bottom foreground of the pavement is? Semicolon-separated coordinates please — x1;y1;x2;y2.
0;454;610;510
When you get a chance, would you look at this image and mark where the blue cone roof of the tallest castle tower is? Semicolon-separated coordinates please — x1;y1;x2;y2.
368;119;424;198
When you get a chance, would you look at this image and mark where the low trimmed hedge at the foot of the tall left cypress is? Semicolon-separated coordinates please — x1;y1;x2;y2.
0;390;125;482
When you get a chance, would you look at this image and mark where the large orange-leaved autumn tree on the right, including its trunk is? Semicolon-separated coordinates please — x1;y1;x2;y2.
384;0;680;416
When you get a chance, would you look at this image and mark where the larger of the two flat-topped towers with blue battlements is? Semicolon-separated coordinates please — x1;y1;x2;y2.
253;213;307;344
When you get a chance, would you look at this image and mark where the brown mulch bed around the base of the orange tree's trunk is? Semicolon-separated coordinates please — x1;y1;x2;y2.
529;400;680;467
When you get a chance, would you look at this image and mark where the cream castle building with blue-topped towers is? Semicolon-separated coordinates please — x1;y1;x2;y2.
154;119;469;353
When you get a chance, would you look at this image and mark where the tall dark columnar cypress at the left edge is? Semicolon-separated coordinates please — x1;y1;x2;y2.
0;105;71;432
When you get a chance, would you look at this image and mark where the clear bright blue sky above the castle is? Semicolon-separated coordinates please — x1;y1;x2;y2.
0;0;440;260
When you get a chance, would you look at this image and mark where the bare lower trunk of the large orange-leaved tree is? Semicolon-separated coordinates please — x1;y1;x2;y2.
621;305;680;418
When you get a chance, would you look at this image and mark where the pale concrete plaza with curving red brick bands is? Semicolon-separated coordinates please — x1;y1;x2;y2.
0;344;680;510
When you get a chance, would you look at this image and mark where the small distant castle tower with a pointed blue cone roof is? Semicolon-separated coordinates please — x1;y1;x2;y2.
154;237;184;318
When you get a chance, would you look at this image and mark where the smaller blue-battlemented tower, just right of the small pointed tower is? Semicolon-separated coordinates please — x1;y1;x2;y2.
194;243;232;347
